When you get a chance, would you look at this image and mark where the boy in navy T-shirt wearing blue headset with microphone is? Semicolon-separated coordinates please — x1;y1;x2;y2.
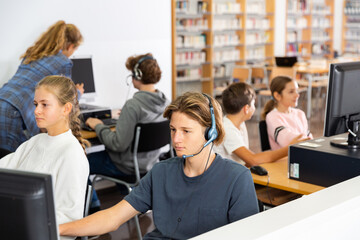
59;93;258;239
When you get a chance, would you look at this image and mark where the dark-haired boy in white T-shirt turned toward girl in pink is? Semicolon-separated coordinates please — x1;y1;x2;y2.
215;83;307;167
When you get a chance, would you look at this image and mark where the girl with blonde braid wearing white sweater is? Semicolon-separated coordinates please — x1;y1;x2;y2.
0;76;89;240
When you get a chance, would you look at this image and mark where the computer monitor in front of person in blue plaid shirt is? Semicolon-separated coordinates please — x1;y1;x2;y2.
71;56;96;99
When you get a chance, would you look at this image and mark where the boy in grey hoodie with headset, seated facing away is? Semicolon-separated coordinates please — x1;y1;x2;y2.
86;53;169;211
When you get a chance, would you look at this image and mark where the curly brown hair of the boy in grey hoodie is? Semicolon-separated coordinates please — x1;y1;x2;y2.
125;53;161;84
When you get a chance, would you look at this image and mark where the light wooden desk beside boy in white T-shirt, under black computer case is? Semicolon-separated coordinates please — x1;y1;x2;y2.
251;157;325;195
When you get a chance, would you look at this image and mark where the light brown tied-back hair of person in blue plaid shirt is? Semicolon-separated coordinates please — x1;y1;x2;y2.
20;20;83;64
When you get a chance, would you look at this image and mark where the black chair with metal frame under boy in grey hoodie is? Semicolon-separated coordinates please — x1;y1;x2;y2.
93;120;173;240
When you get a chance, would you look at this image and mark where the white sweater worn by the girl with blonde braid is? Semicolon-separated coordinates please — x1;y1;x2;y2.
0;130;89;239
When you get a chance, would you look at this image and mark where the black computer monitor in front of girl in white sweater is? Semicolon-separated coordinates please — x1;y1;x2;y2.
0;169;58;240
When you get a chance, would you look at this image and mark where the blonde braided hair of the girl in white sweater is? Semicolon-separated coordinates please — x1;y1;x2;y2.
35;75;90;151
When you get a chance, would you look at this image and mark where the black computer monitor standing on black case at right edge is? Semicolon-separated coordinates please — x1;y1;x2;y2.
324;62;360;148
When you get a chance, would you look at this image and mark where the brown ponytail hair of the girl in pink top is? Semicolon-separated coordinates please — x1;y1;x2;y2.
261;76;292;120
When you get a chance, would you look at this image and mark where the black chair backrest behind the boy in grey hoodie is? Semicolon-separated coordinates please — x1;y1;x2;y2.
131;120;172;185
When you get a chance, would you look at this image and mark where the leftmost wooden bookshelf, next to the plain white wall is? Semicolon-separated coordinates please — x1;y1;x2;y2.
172;0;275;98
